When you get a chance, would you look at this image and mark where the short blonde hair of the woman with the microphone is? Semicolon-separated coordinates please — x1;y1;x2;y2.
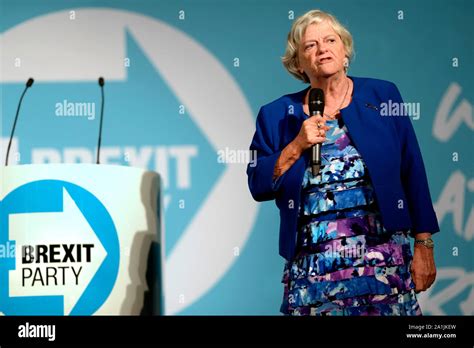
281;10;354;83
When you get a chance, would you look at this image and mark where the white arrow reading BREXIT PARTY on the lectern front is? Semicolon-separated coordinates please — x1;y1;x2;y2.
9;189;107;315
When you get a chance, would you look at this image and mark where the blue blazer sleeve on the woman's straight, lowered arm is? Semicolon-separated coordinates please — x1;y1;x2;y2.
390;84;439;236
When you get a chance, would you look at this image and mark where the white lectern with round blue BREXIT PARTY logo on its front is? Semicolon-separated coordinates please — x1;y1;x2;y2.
0;164;164;315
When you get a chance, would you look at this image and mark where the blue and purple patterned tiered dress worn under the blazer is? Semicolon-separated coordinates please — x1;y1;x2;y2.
280;115;422;315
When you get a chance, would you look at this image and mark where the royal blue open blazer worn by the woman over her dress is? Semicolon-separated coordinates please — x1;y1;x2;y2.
247;77;439;260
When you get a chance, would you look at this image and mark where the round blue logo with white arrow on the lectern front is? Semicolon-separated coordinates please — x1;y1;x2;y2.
0;180;120;315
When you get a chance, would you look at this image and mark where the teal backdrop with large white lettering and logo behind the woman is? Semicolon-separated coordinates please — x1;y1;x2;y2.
0;0;474;315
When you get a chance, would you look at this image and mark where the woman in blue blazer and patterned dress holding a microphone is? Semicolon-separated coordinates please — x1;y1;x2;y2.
247;10;439;315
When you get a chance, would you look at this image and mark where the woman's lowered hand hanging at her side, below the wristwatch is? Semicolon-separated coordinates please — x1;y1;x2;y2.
410;238;436;293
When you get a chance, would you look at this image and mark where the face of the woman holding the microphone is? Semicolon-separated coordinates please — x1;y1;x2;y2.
298;21;346;81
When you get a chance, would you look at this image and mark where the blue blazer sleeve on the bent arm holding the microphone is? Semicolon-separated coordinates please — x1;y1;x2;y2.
247;107;287;202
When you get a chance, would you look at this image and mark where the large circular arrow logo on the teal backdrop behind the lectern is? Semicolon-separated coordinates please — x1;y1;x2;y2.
0;8;258;314
